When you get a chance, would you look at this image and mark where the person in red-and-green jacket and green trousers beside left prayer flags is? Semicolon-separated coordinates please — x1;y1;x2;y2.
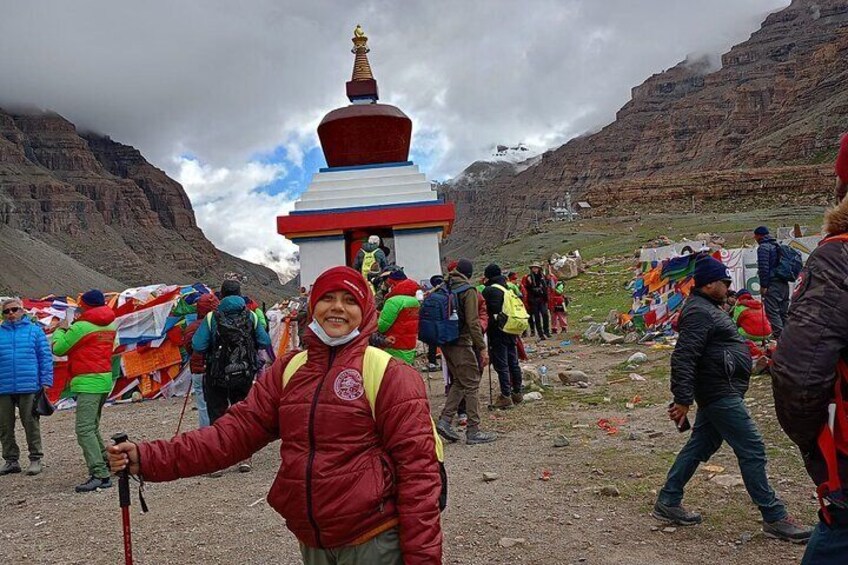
53;289;115;492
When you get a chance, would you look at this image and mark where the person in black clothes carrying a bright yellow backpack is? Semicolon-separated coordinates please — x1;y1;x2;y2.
483;263;524;408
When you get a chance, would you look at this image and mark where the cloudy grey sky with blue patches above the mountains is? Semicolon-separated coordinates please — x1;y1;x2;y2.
0;0;789;278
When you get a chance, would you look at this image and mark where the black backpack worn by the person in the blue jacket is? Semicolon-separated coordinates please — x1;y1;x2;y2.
206;308;259;388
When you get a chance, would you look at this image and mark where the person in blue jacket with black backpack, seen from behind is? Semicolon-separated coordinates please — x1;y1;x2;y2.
191;280;271;473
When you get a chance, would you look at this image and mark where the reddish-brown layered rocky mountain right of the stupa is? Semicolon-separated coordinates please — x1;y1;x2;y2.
441;0;848;254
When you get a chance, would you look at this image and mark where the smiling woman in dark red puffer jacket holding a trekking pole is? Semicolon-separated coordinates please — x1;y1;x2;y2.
109;267;442;565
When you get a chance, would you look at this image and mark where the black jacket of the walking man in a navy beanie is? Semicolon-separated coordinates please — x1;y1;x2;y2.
671;289;751;407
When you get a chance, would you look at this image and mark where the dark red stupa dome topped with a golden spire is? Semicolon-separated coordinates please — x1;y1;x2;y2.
318;26;412;167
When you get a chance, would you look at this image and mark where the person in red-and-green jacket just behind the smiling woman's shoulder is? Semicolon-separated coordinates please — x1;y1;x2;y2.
377;271;421;364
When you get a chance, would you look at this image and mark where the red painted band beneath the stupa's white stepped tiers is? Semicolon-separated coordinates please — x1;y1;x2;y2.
277;202;456;238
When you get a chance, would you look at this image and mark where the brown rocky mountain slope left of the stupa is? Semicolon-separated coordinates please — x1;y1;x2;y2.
0;105;282;302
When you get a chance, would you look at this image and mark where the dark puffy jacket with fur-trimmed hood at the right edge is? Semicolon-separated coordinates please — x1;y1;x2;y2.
771;198;848;485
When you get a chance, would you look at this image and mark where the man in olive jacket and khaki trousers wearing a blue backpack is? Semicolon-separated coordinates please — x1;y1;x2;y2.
436;259;498;445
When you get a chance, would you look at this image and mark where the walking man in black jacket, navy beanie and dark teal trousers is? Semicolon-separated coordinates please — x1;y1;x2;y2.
652;256;811;542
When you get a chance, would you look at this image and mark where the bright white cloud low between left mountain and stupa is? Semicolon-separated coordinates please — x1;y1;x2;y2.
174;157;297;280
